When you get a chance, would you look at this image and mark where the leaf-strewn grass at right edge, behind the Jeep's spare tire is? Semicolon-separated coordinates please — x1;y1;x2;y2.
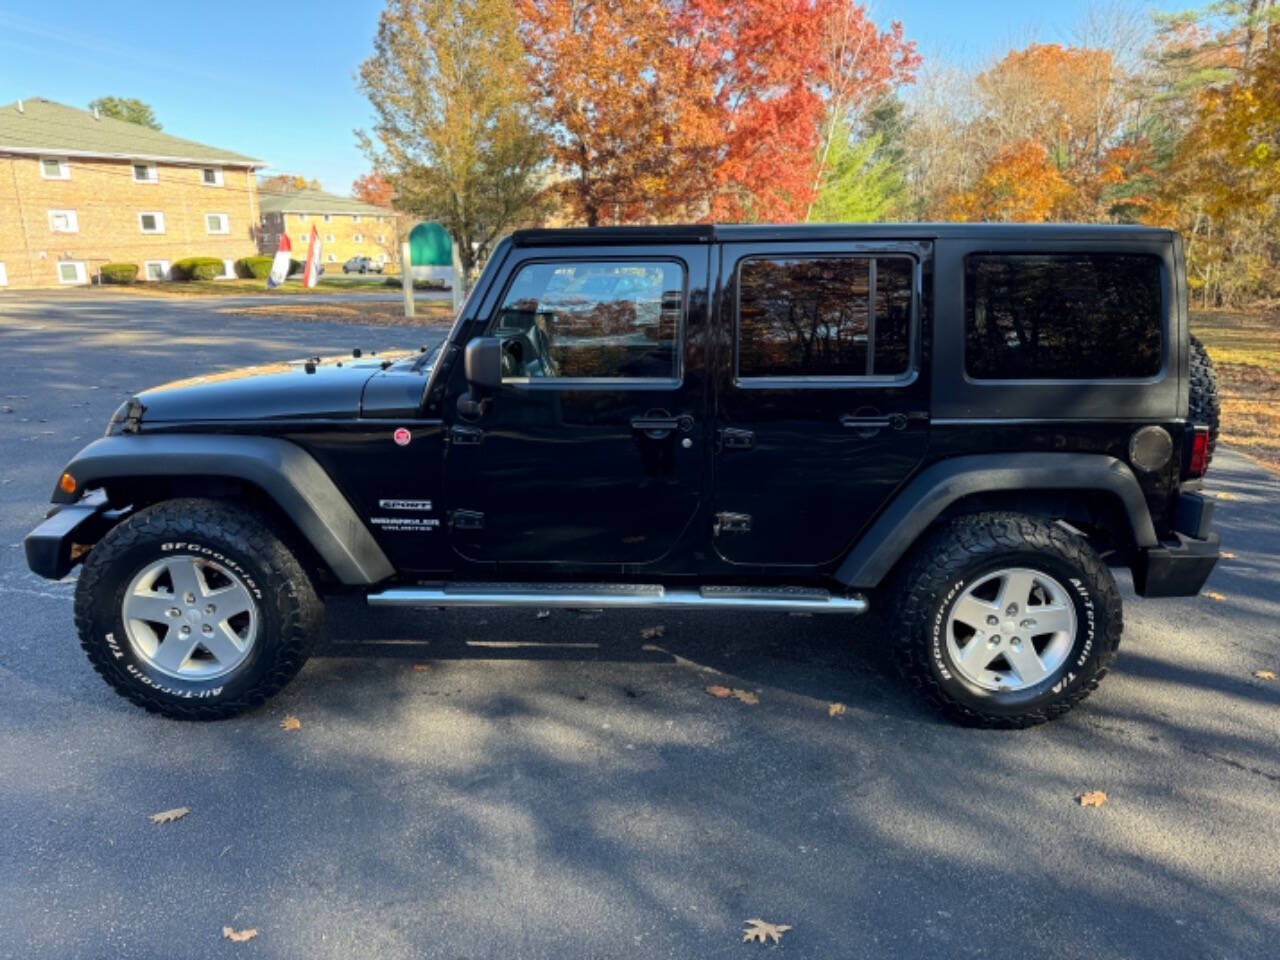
1192;307;1280;468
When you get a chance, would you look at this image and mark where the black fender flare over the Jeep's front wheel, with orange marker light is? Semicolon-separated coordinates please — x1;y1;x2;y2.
52;434;396;586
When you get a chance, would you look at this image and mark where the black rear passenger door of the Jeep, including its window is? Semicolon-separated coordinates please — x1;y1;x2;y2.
714;242;929;566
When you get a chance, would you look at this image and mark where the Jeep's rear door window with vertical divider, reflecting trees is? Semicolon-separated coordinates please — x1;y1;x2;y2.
737;256;914;378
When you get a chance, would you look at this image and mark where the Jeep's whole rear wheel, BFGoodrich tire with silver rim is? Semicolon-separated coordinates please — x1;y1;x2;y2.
895;513;1123;727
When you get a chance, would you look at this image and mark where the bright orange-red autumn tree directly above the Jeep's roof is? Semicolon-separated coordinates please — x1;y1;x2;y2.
518;0;915;224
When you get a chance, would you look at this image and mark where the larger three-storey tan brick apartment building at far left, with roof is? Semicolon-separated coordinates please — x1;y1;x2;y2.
0;99;264;288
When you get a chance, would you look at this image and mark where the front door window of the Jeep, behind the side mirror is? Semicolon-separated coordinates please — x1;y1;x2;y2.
489;260;685;379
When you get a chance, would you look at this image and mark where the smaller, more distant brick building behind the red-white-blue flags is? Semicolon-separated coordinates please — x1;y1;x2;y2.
259;189;398;271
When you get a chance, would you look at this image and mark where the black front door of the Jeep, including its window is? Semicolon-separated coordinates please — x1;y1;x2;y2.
444;246;708;564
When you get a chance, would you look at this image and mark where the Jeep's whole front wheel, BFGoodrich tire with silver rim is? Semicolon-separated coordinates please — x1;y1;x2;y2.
76;499;324;719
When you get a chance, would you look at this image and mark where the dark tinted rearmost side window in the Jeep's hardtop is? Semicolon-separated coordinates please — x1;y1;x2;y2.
965;253;1162;380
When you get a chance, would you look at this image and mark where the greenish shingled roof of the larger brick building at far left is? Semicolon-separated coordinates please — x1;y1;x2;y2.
0;97;265;166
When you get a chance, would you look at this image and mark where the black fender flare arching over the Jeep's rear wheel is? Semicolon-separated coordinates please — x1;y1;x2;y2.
836;453;1158;589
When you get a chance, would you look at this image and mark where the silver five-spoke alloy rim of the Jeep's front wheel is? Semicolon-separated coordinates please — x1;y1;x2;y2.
122;554;257;680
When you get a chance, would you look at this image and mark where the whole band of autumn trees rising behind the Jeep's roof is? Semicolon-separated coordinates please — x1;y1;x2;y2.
360;0;1280;305
